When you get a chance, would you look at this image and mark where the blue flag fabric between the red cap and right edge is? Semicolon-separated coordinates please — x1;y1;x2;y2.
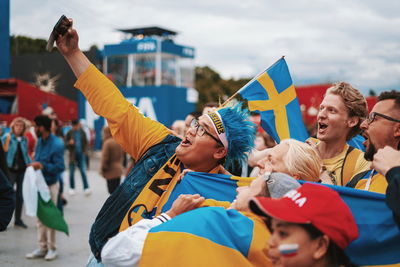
302;181;400;266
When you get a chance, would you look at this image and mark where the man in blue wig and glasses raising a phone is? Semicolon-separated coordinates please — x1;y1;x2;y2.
57;17;255;266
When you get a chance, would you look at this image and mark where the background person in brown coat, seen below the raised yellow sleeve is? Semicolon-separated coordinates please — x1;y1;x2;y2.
100;126;124;195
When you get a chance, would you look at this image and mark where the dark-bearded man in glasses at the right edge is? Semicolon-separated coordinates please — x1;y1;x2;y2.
348;90;400;194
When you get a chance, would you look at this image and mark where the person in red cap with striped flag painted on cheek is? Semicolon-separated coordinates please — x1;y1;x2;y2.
249;183;358;267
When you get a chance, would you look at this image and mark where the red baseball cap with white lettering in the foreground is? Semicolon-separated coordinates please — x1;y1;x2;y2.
250;183;358;249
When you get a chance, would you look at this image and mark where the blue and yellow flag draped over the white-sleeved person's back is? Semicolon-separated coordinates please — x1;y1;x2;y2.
139;207;271;267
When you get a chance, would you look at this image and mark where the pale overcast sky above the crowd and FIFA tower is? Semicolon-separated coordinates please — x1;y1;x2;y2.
10;0;400;93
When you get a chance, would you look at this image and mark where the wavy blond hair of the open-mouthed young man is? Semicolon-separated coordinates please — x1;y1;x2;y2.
325;82;368;140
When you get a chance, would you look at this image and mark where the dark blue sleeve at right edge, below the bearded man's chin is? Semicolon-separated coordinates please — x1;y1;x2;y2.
386;166;400;227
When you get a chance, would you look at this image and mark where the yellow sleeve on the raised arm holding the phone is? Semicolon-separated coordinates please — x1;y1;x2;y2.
74;65;170;160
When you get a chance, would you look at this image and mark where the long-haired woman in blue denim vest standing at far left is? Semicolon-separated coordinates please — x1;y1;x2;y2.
3;117;31;229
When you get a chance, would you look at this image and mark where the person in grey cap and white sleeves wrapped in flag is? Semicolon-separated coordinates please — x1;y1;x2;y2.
101;173;300;266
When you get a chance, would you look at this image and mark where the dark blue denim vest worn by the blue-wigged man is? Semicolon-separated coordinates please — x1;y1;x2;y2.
89;135;182;260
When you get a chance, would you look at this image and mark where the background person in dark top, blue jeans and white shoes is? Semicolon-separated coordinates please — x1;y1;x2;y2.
65;119;92;196
